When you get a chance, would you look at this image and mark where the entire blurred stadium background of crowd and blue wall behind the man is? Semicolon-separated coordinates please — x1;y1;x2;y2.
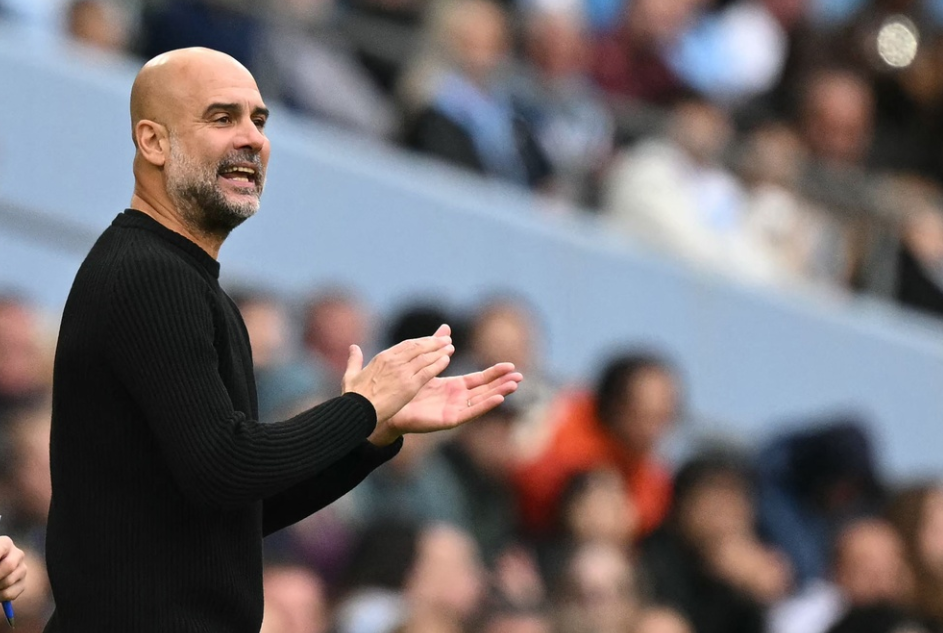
0;0;943;633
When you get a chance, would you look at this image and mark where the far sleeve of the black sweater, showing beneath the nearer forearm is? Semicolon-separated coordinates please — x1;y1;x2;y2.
262;438;403;536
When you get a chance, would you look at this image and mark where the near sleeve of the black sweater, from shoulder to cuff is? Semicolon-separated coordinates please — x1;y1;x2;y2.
107;249;376;509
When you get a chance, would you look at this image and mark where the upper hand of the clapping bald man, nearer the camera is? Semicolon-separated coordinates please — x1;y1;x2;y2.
343;326;455;426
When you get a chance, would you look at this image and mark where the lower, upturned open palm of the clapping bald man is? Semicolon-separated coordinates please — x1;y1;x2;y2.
390;363;523;433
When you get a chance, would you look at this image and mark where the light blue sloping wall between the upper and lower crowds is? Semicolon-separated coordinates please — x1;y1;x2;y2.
0;24;943;477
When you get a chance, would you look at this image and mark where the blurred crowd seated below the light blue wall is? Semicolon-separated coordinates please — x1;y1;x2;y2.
0;287;943;633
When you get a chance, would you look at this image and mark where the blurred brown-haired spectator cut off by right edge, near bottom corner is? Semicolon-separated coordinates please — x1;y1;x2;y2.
889;482;943;631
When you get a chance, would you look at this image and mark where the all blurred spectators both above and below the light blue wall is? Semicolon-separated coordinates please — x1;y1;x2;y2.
0;0;943;633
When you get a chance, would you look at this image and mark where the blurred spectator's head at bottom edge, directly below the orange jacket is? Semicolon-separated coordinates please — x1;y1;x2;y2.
554;543;641;633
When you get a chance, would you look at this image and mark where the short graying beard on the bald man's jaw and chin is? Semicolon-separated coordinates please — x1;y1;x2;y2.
167;137;262;238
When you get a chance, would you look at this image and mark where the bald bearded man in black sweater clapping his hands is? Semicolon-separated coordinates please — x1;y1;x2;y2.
46;49;522;633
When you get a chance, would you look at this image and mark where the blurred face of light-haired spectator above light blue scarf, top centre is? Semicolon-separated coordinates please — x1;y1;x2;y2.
446;0;509;85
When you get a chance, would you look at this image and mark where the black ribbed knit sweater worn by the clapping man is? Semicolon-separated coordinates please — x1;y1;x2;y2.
46;210;401;633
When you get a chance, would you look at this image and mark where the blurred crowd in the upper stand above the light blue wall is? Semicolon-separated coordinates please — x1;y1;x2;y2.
7;0;943;314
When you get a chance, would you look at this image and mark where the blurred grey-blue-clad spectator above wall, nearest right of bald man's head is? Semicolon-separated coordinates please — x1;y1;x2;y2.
251;0;397;138
